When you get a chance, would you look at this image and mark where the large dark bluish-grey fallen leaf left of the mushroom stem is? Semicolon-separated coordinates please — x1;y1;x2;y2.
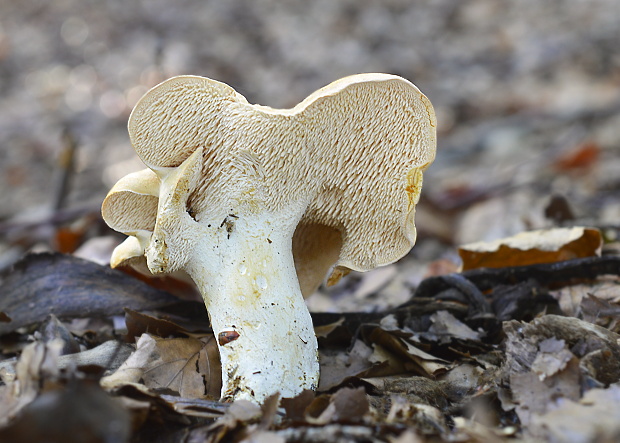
0;253;178;335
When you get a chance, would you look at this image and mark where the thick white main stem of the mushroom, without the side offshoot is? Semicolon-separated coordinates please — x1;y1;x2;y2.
186;210;319;403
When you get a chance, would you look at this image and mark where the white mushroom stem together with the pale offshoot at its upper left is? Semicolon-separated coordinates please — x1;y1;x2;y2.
146;150;319;403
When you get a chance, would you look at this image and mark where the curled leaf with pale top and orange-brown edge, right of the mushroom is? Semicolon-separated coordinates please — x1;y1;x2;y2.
459;227;602;271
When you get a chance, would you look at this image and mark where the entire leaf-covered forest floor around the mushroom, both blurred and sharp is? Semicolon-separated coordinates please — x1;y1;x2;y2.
0;0;620;442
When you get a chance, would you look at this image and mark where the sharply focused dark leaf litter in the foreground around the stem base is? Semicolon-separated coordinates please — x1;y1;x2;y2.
0;229;620;442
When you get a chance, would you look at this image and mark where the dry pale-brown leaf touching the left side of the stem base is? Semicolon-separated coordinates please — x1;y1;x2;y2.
101;334;221;398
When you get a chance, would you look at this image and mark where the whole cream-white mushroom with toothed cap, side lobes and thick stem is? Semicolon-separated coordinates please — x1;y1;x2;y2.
102;74;436;403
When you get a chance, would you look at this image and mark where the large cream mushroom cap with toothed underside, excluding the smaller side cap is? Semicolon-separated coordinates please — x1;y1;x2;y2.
126;74;436;293
